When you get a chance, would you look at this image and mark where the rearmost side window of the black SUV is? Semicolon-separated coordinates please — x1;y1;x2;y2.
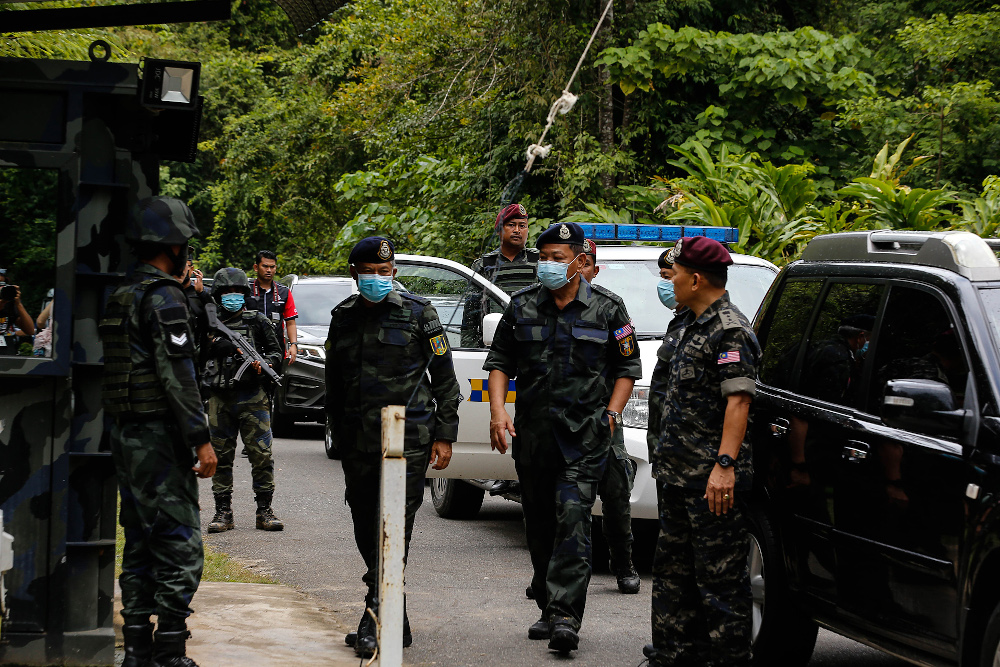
760;280;823;389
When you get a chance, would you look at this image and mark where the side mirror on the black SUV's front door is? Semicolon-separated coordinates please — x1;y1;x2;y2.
882;380;966;438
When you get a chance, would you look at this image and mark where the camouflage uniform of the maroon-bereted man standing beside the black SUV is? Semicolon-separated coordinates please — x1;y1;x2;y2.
649;293;759;666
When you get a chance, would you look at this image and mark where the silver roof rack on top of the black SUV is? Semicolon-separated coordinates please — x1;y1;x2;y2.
802;230;1000;281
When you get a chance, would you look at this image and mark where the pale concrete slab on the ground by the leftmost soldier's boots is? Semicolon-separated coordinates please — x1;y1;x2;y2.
115;582;359;667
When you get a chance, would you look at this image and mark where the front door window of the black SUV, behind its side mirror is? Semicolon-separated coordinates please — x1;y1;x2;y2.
868;285;968;414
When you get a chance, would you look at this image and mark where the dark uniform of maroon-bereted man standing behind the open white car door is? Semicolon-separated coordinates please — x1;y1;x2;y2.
462;248;538;347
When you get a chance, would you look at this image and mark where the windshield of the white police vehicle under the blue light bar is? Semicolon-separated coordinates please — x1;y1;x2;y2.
594;260;775;337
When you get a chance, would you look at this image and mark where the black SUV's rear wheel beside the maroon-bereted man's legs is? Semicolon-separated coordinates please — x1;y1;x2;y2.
747;507;819;667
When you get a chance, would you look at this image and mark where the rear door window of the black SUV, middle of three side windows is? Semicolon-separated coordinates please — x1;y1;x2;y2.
799;283;883;405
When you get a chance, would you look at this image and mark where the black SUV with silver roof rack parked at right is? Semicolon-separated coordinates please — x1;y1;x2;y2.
750;231;1000;667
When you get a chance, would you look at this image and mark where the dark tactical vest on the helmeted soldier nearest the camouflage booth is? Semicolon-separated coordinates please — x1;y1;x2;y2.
99;278;177;417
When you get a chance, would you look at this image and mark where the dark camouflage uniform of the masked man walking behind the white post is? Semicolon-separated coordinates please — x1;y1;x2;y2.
326;291;459;606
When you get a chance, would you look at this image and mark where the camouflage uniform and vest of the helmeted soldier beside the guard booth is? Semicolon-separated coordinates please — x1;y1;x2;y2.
101;264;208;625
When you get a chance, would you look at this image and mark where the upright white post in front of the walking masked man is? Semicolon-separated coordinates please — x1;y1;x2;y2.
378;405;406;667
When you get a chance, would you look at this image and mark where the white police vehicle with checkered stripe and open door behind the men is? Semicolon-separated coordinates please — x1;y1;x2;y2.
386;237;778;519
